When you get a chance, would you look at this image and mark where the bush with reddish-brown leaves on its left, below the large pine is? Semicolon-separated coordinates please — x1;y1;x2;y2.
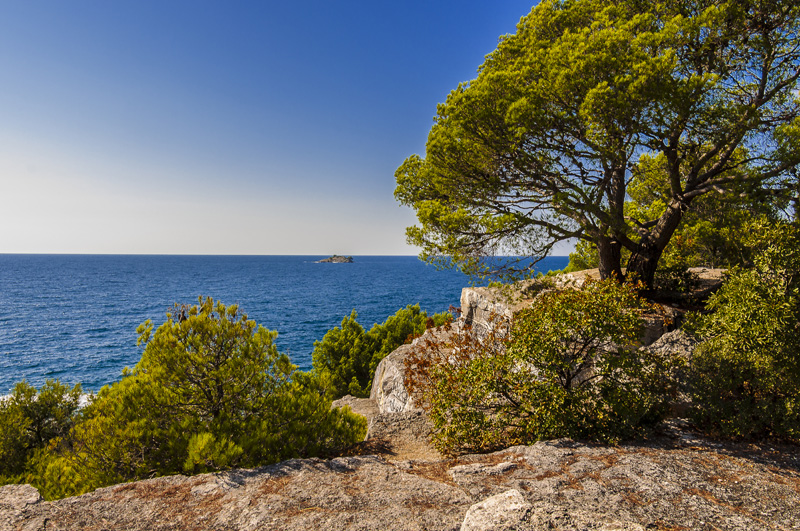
406;281;677;454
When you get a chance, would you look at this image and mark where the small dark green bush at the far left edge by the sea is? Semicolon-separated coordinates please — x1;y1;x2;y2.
0;380;81;482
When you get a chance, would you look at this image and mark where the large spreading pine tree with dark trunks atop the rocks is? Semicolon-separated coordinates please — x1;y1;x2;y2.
395;0;800;286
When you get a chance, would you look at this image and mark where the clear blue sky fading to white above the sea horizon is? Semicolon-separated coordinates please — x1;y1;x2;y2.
0;0;544;255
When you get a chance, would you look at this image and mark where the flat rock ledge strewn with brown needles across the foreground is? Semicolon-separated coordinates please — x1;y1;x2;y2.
0;434;800;531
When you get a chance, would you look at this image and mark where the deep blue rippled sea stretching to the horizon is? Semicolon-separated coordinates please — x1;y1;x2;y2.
0;255;568;395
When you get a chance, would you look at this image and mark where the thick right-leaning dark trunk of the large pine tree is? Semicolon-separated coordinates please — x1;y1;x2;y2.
625;199;689;289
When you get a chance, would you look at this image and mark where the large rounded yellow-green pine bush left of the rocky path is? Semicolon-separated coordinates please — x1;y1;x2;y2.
17;298;366;498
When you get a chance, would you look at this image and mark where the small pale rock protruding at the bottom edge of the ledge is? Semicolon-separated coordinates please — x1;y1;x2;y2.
461;489;533;531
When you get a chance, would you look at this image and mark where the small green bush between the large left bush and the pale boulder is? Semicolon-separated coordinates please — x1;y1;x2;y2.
311;305;452;398
